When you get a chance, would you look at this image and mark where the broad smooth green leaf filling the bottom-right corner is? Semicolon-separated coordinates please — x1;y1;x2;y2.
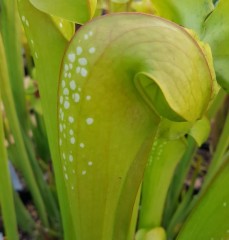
177;162;229;240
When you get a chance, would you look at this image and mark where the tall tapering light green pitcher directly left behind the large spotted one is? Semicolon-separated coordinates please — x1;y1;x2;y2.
18;0;74;239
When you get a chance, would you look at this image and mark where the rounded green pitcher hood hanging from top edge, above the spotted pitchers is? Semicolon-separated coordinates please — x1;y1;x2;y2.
30;0;97;24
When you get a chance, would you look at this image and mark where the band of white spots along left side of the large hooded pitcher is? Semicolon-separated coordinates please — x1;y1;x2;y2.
58;30;98;191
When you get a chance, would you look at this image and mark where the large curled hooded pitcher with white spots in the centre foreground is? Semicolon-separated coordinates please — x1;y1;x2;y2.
58;14;214;240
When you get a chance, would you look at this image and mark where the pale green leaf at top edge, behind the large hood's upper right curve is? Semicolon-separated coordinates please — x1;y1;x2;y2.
151;0;214;33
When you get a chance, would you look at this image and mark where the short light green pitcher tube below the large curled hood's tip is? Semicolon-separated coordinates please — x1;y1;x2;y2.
138;138;186;229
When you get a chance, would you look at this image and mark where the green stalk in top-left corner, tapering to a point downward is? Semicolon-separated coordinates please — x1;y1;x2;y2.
0;0;28;130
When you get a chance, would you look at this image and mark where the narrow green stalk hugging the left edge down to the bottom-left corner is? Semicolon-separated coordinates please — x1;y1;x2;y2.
0;78;19;240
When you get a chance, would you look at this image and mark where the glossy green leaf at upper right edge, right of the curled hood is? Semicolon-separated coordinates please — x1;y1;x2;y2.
202;0;229;92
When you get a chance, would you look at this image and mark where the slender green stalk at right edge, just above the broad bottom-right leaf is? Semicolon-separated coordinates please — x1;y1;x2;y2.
203;111;229;187
